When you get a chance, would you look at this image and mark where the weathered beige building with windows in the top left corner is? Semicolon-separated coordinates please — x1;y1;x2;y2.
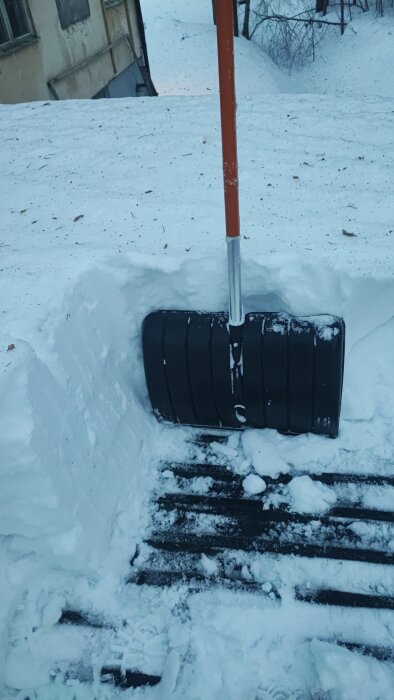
0;0;156;103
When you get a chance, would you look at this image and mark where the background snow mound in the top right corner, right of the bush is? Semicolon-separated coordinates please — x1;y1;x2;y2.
293;8;394;100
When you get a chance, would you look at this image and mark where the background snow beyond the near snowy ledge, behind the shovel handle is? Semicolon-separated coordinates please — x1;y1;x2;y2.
142;0;394;100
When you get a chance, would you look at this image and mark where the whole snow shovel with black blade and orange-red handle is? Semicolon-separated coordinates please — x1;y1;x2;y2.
142;0;345;437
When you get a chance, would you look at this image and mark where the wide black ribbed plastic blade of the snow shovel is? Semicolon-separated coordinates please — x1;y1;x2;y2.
142;311;345;437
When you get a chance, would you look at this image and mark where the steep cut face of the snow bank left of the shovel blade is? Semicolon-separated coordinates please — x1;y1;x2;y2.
0;265;195;692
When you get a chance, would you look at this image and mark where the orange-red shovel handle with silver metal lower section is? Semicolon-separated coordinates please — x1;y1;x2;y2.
216;0;244;326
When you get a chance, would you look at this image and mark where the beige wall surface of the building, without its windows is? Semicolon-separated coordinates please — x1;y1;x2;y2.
0;0;142;103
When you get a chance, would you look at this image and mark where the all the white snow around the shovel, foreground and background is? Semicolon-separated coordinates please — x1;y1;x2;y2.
0;0;394;700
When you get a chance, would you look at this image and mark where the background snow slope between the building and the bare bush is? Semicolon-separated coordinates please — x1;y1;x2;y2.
142;0;288;95
